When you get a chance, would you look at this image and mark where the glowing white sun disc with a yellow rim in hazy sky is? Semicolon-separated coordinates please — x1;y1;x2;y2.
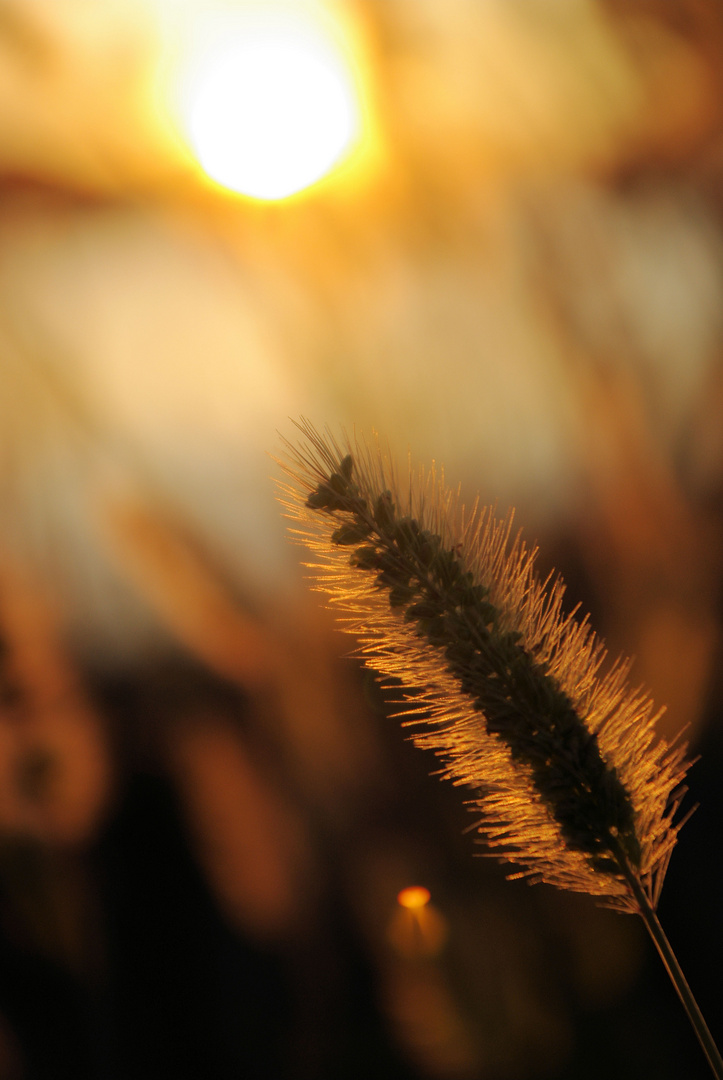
181;16;360;200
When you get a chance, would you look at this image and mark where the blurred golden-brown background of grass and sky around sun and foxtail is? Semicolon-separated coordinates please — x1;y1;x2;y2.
0;0;723;1080
